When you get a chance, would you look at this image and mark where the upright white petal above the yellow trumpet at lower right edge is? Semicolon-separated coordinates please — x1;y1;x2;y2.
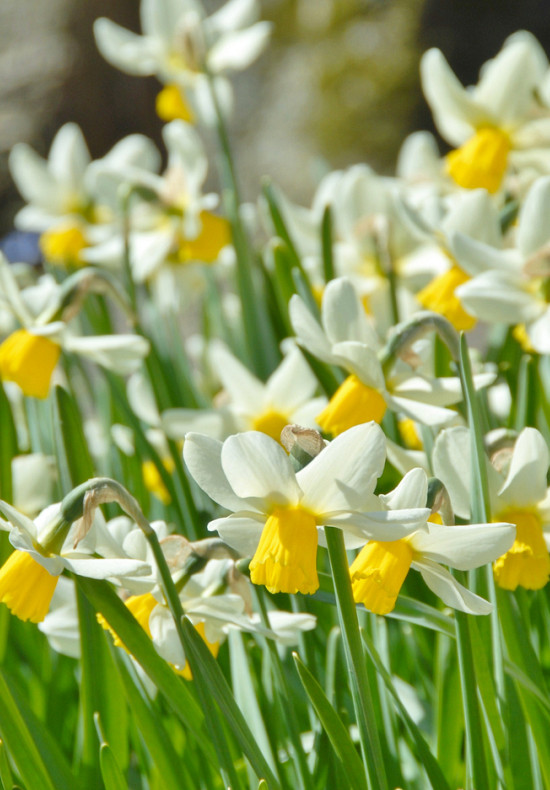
498;428;549;507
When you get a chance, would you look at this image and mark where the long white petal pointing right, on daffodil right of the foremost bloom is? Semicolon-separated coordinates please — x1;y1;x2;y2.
411;523;516;571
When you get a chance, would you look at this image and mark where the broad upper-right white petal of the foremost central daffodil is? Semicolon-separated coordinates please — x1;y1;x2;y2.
297;422;386;514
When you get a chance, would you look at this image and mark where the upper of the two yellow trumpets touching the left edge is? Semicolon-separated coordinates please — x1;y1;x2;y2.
0;329;61;398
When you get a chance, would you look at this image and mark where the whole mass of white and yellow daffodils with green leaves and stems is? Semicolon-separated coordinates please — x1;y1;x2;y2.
0;0;550;790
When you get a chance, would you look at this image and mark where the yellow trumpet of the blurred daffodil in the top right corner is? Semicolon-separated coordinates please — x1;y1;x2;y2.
446;127;510;192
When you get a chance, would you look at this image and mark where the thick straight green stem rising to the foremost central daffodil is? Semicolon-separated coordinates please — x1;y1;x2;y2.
325;527;388;790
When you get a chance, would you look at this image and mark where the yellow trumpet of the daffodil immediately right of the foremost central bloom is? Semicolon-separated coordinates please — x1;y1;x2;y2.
349;540;413;614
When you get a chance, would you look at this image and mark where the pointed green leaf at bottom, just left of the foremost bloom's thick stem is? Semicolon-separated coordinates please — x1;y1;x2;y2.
293;653;367;790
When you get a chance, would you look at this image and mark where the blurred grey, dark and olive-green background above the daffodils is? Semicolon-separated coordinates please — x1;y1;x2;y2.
0;0;550;235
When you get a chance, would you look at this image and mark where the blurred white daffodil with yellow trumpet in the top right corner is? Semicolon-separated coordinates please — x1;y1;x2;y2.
420;31;550;192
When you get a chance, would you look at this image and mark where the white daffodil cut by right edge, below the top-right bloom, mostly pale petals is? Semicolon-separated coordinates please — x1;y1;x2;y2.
453;176;550;354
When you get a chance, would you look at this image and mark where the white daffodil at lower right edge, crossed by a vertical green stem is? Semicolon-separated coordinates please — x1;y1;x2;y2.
433;428;550;590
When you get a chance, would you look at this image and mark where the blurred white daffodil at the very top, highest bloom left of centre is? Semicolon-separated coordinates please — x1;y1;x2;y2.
94;0;271;121
